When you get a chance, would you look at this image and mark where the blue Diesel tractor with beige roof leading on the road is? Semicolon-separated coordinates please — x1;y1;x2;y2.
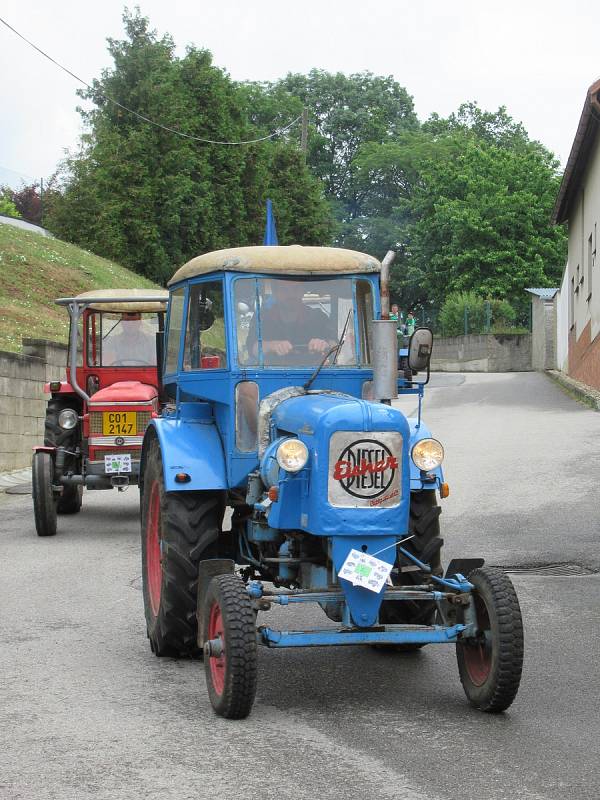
140;246;523;718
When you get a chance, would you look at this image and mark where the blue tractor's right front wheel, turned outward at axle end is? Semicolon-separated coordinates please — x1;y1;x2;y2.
456;567;523;712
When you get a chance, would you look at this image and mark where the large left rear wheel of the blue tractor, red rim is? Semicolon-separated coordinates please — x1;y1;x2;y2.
141;439;225;657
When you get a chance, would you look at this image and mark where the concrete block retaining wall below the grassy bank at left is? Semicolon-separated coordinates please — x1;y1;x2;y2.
0;339;67;472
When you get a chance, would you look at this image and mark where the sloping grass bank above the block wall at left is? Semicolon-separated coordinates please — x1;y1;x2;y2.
0;224;159;352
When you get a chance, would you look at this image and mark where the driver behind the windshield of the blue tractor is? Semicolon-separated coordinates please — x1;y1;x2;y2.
246;280;335;364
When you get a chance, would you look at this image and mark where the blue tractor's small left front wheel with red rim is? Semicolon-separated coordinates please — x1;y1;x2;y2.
202;574;257;719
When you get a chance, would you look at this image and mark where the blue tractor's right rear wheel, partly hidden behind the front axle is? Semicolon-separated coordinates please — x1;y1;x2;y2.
378;490;444;640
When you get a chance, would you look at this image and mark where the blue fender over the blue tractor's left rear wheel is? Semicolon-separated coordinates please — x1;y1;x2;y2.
142;416;228;492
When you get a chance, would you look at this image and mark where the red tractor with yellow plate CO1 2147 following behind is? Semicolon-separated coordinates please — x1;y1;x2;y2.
32;289;168;536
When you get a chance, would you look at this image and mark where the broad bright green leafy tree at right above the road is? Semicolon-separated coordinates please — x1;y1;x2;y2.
354;104;565;308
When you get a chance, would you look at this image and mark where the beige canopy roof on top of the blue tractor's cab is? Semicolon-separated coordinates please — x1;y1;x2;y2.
169;244;381;286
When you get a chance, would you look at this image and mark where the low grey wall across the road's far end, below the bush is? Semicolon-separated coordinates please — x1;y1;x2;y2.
431;333;532;372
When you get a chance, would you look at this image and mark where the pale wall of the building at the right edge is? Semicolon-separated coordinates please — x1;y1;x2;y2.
568;130;600;388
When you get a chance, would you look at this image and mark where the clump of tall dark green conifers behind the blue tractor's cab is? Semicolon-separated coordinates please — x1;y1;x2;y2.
48;11;331;282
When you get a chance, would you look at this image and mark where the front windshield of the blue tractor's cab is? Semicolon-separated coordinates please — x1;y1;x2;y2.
234;278;373;368
